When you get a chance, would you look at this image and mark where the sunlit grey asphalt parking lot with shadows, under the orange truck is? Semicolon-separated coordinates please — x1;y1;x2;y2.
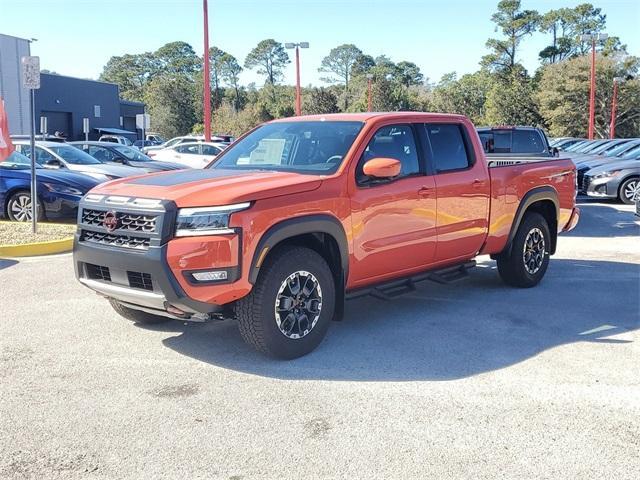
0;201;640;479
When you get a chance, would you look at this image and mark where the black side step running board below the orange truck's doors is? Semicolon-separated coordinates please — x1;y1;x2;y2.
345;260;476;300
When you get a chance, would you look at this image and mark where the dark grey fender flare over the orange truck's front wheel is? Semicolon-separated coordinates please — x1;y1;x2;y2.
249;214;349;284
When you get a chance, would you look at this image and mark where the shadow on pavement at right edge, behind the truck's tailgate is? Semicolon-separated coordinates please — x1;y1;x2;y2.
563;199;640;237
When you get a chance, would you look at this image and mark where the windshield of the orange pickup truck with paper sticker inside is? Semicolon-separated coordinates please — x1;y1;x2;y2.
211;121;363;174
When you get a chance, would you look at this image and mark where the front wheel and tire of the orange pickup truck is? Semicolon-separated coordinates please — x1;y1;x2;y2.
235;246;336;359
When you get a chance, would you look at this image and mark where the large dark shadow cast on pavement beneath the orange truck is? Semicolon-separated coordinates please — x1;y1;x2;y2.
148;259;640;381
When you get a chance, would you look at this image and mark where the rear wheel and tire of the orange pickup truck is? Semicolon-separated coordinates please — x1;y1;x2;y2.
497;213;551;288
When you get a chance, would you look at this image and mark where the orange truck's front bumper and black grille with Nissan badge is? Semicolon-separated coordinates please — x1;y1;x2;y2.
73;194;251;320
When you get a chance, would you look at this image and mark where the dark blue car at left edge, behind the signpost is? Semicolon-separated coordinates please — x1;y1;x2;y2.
0;152;100;222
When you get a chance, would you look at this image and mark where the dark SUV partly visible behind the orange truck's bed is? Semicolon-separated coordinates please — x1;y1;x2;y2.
477;127;558;158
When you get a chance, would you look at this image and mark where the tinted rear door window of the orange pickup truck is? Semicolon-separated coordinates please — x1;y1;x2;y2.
425;124;472;172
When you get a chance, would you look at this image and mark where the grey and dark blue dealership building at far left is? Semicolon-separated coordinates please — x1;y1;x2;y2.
0;34;144;140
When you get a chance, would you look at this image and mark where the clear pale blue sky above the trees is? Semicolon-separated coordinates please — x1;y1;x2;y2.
0;0;640;85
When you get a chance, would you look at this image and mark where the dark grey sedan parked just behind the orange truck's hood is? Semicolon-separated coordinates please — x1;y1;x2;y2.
71;141;187;172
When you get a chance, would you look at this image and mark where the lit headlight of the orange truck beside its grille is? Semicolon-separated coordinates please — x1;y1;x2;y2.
176;202;251;237
